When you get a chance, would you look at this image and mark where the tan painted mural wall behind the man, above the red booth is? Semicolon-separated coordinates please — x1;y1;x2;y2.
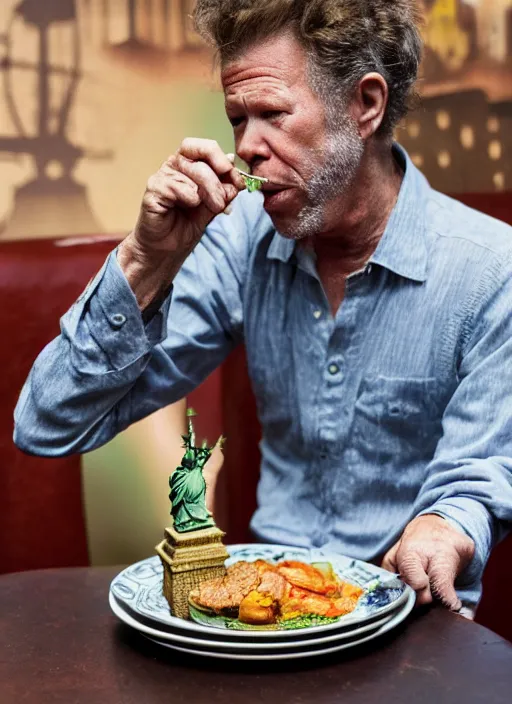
0;0;512;239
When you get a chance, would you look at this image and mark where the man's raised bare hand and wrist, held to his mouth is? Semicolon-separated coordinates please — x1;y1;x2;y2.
118;139;245;309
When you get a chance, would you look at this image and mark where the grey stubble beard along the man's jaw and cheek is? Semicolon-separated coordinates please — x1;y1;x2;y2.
279;114;364;240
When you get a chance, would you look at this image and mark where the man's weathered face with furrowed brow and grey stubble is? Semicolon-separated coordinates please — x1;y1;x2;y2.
222;34;363;239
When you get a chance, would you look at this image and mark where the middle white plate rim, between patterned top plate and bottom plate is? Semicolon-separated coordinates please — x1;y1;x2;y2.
109;592;394;653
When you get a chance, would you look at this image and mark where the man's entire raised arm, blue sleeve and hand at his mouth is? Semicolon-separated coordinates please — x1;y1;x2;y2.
14;140;251;456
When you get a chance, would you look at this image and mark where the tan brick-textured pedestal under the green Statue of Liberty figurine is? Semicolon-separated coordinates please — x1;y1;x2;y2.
155;526;229;618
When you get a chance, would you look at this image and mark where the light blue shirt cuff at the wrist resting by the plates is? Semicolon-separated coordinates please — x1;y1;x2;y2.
419;496;493;586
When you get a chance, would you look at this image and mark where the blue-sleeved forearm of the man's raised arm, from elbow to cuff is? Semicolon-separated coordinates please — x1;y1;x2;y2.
14;252;171;457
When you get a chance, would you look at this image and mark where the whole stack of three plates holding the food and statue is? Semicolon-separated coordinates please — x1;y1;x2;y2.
109;544;415;660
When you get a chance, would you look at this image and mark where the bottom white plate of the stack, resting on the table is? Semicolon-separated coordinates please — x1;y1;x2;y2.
142;592;416;660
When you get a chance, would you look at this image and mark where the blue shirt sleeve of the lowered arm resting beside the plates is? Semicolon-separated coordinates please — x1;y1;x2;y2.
415;250;512;602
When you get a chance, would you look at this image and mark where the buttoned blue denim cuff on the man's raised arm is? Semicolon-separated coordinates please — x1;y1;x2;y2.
63;249;171;371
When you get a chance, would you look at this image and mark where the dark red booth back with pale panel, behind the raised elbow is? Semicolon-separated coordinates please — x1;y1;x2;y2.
0;236;229;573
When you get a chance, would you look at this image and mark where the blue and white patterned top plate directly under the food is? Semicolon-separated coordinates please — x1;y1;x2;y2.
110;544;412;640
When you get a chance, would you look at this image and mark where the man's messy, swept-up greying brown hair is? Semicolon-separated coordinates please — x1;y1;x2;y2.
194;0;422;136
